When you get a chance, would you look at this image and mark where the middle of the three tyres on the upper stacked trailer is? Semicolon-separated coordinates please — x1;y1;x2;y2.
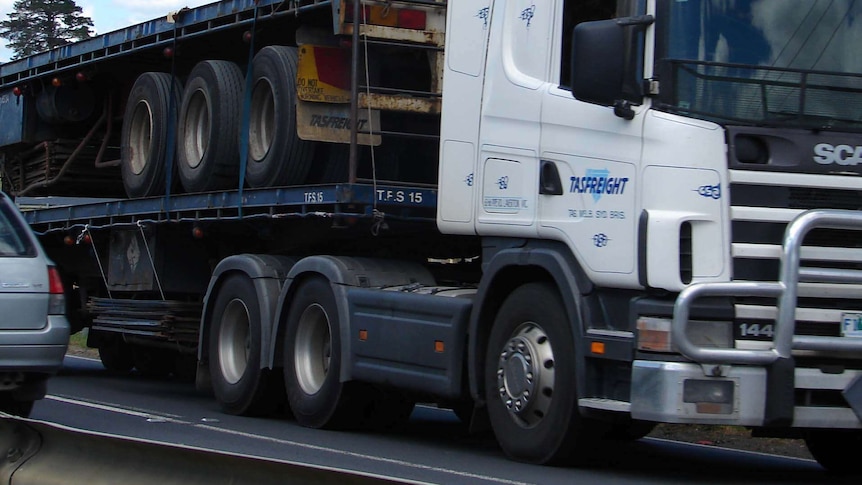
177;61;244;192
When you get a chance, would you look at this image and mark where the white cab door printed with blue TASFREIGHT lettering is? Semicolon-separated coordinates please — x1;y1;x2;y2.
538;0;643;283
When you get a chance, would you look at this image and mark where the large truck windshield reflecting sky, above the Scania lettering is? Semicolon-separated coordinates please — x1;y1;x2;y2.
656;0;862;131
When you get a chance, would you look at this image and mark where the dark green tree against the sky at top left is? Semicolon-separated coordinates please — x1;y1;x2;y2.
0;0;93;59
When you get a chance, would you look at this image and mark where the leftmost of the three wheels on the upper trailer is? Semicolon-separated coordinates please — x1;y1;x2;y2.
120;72;182;197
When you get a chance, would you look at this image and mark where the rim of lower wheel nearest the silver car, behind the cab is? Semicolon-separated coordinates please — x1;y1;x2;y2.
218;299;251;384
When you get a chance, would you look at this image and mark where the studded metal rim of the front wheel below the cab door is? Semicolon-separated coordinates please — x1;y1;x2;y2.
497;322;555;428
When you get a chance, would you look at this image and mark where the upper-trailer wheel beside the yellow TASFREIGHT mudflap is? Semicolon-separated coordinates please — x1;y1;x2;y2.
245;46;314;187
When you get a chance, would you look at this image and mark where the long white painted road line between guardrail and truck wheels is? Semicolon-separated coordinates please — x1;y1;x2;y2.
45;395;529;485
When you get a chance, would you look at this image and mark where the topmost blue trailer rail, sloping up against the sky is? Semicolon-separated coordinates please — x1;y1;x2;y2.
0;0;338;89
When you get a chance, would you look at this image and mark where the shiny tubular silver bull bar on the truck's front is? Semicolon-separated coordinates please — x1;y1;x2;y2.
671;210;862;365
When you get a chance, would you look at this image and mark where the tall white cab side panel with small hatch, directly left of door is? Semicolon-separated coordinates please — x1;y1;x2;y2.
476;0;556;237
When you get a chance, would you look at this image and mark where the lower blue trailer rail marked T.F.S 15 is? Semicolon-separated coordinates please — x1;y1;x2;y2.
18;184;437;234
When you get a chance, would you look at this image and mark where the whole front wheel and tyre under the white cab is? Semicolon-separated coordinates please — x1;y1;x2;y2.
485;283;596;464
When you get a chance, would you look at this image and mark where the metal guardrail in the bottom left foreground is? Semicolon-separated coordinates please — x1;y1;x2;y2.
0;414;420;485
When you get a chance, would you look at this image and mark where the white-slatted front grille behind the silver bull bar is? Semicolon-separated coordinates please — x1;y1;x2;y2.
730;170;862;344
